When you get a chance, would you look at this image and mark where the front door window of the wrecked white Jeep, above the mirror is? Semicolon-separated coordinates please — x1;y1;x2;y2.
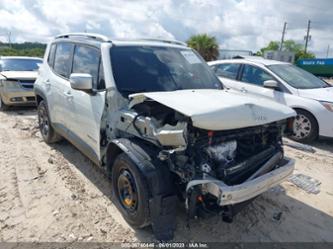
72;45;100;89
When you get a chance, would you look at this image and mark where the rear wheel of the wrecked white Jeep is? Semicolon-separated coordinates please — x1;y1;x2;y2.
37;100;61;144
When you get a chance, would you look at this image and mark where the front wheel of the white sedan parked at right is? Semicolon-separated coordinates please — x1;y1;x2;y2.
291;110;319;143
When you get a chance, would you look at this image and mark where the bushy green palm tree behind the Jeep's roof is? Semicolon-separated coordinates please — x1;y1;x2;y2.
187;34;219;61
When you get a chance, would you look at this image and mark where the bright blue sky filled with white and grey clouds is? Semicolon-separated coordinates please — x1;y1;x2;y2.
0;0;333;57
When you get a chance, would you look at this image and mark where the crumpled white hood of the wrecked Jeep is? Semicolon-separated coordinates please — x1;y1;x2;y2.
129;89;296;130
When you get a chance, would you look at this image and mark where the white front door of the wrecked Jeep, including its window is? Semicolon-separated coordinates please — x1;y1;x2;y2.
69;44;105;161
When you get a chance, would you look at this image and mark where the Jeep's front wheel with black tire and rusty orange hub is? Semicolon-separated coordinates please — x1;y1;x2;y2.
112;153;150;228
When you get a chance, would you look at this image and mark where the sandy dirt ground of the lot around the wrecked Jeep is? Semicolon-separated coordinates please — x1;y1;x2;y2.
0;109;333;242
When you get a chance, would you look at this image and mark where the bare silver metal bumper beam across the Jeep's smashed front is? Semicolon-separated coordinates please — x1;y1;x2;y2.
203;158;295;206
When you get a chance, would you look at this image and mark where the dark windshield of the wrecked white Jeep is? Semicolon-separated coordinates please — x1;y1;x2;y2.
111;46;222;95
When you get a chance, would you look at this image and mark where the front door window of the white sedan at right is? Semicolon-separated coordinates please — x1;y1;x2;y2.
242;65;274;86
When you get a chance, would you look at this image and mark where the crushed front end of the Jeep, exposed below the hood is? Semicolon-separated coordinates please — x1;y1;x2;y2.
111;94;294;221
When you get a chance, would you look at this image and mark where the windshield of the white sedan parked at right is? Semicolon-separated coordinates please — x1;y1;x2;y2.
268;64;329;89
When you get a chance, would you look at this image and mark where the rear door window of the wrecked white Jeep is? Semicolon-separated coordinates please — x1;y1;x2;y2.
53;43;73;78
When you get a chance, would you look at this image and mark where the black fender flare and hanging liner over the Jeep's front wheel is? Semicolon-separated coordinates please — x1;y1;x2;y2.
106;138;177;241
